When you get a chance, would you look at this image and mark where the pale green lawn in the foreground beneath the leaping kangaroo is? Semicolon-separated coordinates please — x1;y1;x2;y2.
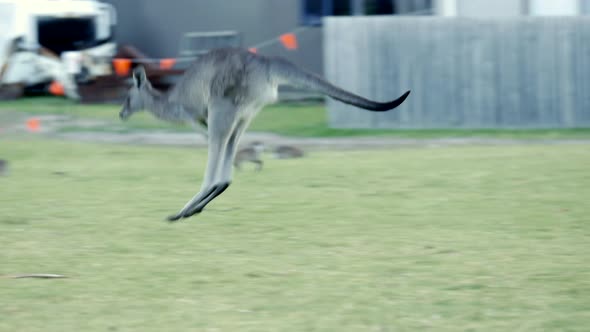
0;139;590;332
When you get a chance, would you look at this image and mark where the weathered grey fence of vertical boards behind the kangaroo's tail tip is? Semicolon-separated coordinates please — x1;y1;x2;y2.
324;16;590;128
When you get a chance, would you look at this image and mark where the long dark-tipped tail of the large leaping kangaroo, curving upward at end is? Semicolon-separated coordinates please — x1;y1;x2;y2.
269;58;410;112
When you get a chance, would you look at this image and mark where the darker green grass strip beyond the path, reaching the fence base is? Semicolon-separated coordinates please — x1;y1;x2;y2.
0;97;590;139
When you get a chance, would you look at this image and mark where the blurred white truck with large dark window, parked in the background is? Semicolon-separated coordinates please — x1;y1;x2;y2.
0;0;116;99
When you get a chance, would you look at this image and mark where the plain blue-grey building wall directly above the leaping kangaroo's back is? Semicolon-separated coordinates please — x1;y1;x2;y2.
105;0;323;73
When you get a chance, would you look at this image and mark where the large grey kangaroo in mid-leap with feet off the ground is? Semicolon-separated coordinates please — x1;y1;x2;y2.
119;48;410;221
